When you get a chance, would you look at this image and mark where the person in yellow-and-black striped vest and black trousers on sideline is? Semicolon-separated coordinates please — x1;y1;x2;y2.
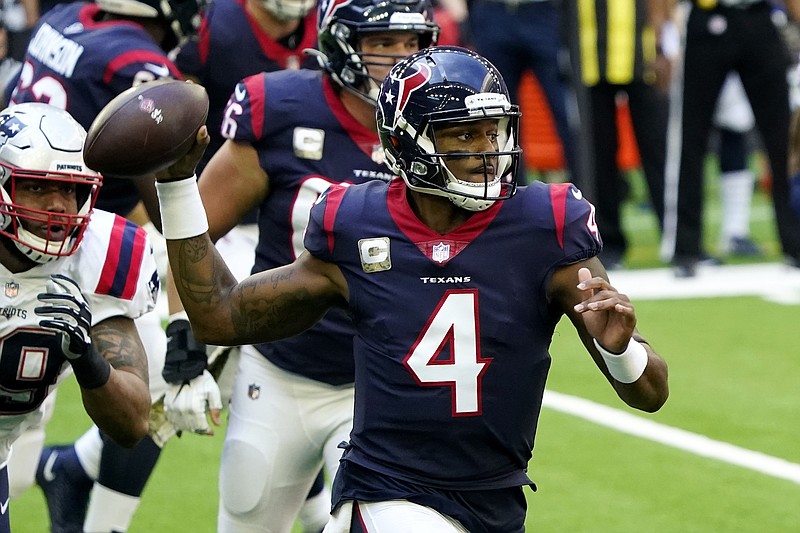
573;0;677;269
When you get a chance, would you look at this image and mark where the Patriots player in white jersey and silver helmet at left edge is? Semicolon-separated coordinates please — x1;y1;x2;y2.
0;103;153;533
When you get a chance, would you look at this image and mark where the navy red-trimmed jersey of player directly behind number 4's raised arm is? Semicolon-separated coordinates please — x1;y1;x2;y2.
222;69;392;385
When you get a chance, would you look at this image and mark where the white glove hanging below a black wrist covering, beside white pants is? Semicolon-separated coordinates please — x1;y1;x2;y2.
164;370;222;435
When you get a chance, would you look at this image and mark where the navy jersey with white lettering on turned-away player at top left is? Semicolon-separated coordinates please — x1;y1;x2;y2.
11;2;180;216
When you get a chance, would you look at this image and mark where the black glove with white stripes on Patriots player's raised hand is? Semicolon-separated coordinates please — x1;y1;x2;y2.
34;274;111;389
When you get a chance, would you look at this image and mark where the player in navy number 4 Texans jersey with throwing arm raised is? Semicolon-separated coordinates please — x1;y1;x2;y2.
157;47;668;533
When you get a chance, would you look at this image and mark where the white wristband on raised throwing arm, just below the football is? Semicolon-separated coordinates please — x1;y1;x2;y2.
156;176;208;240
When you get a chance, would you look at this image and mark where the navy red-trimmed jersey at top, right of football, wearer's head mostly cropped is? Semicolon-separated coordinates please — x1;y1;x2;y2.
175;0;318;175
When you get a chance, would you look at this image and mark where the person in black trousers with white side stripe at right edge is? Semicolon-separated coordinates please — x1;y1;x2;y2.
661;0;800;277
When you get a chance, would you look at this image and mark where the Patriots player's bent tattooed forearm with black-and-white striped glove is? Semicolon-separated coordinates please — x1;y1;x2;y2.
35;274;150;446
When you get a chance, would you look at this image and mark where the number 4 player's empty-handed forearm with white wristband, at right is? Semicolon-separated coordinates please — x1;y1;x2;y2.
549;258;669;412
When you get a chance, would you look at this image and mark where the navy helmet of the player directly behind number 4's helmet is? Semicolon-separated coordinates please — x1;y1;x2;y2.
309;0;439;104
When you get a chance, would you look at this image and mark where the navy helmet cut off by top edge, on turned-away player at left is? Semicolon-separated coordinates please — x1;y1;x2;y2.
95;0;205;52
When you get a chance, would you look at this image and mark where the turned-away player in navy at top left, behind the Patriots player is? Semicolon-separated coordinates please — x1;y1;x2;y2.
5;0;206;532
